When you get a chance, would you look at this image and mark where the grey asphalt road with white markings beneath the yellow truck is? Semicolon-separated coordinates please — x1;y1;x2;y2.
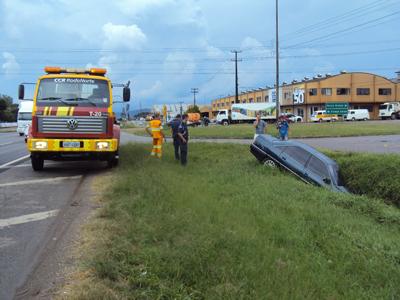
0;133;107;300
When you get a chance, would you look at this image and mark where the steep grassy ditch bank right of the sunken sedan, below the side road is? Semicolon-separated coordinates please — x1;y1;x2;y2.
328;153;400;207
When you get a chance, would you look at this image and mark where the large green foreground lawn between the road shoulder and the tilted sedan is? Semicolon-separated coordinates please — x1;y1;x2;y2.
66;144;400;299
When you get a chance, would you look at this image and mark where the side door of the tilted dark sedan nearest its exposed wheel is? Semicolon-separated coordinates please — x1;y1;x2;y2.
280;146;311;182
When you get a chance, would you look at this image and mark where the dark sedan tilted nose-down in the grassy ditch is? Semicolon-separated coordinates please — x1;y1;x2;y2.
250;135;347;192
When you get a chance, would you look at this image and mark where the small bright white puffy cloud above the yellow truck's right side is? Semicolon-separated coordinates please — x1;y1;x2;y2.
103;22;147;50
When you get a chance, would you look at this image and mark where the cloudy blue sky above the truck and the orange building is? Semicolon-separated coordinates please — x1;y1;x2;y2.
0;0;400;108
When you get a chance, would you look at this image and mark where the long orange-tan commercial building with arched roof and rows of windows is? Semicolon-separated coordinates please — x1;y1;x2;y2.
212;71;400;121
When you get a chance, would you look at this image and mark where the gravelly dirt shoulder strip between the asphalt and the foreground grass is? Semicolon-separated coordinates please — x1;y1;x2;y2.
15;175;107;299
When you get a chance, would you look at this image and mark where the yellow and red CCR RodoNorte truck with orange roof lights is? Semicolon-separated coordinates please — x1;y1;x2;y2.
18;67;131;171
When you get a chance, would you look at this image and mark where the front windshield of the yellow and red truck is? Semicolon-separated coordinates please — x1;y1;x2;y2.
36;77;110;107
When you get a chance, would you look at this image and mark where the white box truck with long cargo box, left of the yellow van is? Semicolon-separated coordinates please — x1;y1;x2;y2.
216;102;276;125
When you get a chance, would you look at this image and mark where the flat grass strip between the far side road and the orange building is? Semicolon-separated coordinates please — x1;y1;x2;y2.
125;122;400;139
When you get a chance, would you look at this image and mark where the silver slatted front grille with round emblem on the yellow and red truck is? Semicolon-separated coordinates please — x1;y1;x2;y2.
38;117;107;134
